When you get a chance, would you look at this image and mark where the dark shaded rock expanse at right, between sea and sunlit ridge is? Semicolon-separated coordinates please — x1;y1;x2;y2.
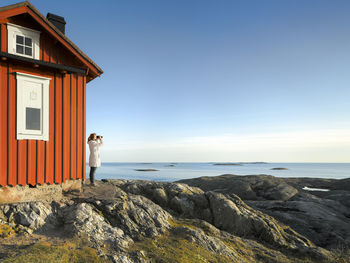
181;175;350;249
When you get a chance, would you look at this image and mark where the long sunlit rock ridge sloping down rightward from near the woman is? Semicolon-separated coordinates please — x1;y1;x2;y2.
107;180;313;249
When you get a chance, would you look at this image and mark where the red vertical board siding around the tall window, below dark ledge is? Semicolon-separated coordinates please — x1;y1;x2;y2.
0;64;86;186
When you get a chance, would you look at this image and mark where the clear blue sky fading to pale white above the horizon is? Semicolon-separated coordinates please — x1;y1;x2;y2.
1;0;350;162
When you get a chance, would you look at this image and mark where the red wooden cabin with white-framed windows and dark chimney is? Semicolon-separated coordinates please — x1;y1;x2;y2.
0;1;103;186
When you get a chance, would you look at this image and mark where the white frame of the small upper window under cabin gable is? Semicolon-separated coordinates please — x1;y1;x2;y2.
7;23;41;59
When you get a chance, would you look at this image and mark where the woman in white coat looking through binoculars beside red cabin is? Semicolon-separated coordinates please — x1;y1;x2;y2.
87;133;103;185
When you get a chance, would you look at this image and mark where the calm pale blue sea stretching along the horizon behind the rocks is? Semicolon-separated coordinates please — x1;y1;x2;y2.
86;163;350;182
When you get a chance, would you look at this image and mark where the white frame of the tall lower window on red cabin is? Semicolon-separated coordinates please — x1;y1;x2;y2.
16;72;51;141
